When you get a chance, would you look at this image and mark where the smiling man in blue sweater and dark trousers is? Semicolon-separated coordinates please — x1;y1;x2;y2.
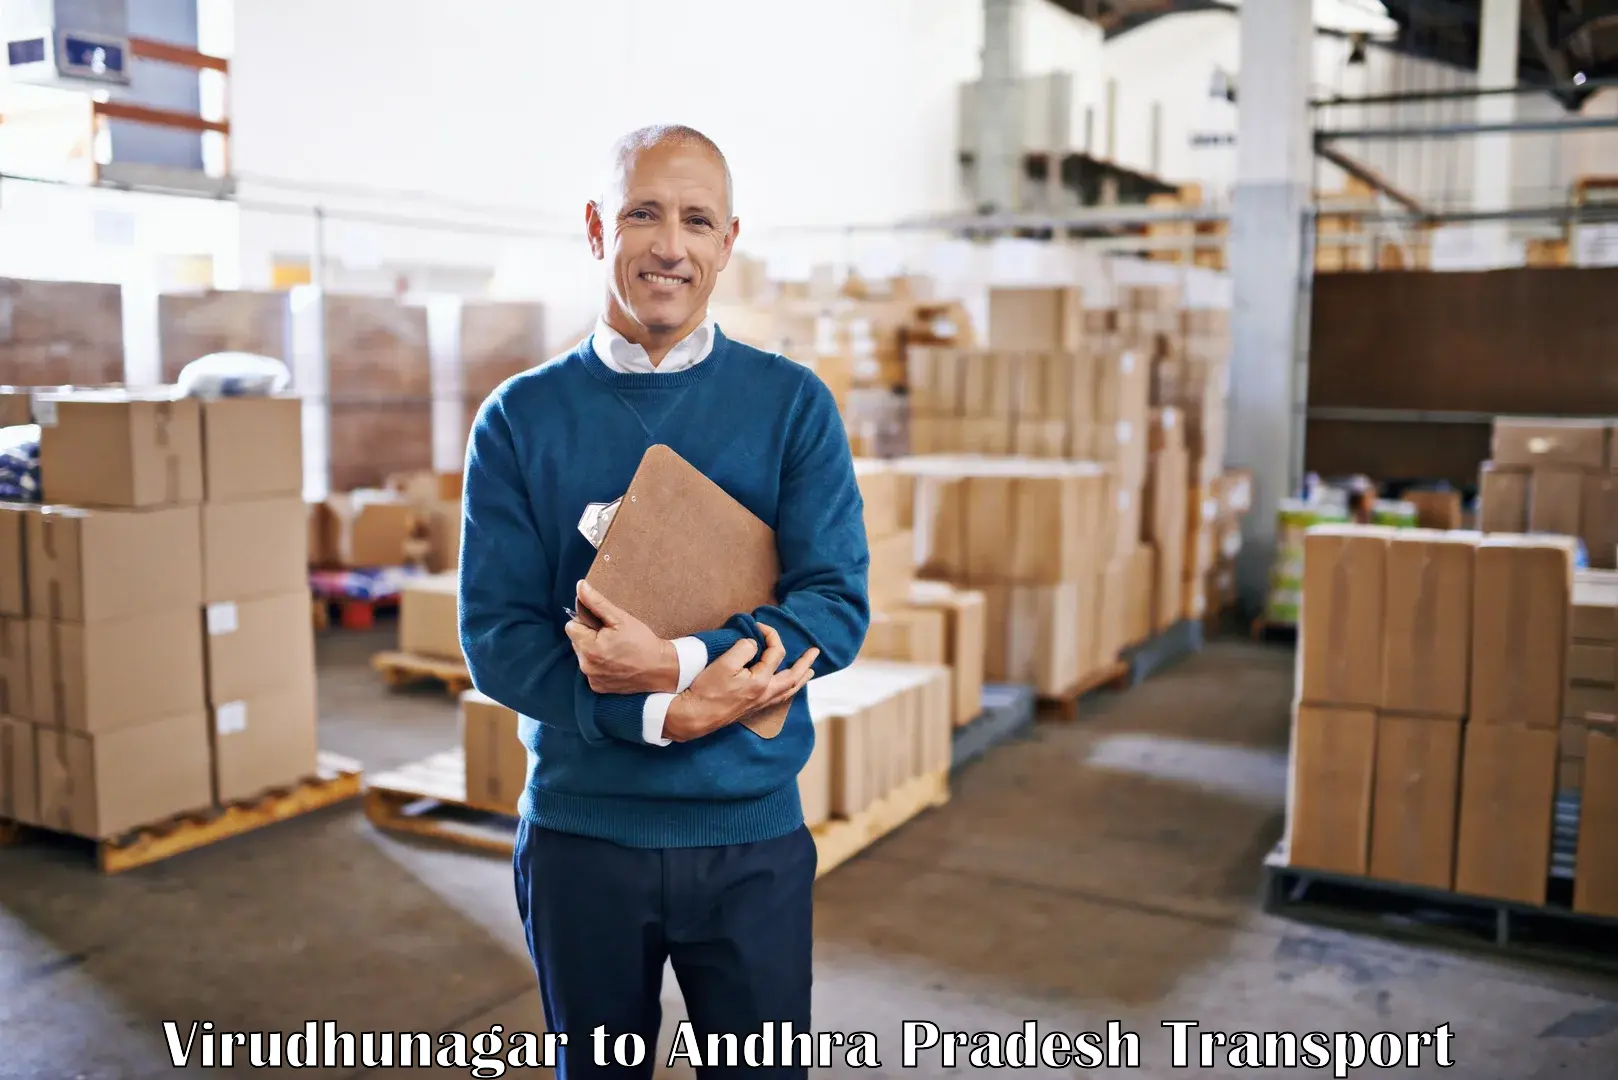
460;126;870;1078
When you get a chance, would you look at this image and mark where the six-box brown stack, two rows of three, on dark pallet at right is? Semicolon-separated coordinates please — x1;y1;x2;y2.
1288;525;1573;904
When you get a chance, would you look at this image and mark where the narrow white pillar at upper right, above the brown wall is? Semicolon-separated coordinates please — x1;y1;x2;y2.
1472;0;1523;257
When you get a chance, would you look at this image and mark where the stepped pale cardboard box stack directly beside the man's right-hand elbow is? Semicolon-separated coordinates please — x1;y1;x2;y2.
854;460;985;725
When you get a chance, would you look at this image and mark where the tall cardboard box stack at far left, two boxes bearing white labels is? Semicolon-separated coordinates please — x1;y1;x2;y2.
0;390;317;837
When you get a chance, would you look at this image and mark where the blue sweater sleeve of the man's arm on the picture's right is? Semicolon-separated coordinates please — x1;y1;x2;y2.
696;372;870;675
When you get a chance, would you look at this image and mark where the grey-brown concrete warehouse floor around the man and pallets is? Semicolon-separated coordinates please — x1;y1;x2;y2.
0;635;1618;1080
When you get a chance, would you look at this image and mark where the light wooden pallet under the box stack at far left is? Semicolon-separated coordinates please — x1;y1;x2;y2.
0;751;364;874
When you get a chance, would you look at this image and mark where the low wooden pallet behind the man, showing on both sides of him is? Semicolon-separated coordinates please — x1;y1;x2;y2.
364;750;950;876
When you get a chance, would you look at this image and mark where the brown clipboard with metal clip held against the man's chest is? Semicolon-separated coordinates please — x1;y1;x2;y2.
574;444;791;738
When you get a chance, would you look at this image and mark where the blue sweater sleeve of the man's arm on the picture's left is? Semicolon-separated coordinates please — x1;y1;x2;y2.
458;395;669;743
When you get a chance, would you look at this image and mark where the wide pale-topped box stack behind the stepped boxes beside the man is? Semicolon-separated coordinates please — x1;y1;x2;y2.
895;457;1119;696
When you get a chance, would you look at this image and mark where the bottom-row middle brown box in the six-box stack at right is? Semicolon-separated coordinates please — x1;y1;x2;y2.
1369;712;1461;889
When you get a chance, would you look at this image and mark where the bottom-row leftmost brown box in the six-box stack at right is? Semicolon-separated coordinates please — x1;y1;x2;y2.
1288;704;1377;874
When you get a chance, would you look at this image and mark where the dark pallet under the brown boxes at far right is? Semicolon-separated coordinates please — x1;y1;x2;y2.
1264;792;1618;972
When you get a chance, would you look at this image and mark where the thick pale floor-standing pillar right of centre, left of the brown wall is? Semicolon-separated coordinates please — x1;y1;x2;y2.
1228;0;1314;610
